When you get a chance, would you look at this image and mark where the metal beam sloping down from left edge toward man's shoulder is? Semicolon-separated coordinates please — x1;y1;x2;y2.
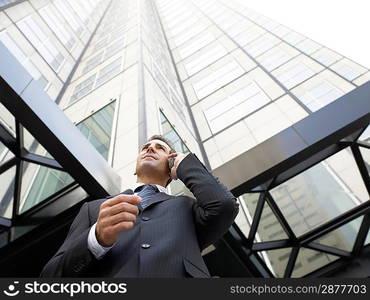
0;48;120;198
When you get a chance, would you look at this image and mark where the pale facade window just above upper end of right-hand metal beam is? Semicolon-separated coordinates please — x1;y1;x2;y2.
299;80;344;112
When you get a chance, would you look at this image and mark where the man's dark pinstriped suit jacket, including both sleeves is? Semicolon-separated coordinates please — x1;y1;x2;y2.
41;153;238;278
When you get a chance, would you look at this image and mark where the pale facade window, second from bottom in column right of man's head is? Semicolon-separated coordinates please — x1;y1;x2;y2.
193;61;244;99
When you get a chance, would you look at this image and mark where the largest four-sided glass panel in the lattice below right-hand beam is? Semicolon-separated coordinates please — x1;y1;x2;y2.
270;152;364;235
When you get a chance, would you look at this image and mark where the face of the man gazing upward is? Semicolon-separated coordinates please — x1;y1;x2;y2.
136;140;171;176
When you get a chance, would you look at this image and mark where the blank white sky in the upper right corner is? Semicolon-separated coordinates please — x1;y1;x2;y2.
242;0;370;68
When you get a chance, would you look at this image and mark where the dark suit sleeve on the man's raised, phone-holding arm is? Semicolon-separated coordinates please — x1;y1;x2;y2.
177;153;239;249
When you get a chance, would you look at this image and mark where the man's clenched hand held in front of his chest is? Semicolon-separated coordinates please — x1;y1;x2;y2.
95;194;142;247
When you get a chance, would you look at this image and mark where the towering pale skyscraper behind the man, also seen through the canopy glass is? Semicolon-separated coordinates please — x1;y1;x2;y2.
0;0;370;277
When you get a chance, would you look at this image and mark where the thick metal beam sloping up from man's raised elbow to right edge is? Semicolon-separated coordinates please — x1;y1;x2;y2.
213;82;370;195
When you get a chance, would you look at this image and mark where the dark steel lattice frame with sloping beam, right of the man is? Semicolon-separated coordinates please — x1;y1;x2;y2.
214;82;370;277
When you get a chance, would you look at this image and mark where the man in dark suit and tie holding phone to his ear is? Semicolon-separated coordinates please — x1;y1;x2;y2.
40;135;238;278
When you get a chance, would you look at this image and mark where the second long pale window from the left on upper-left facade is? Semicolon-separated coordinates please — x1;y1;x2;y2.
17;17;64;71
